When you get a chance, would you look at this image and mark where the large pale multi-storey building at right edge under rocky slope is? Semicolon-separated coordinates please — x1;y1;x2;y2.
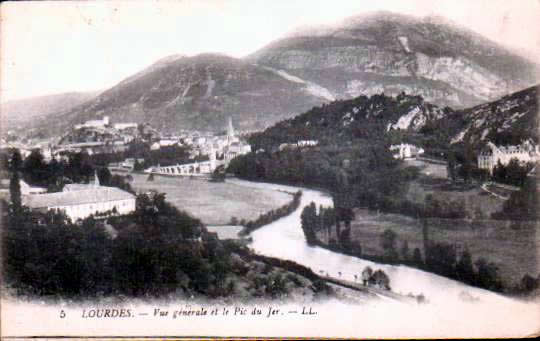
478;141;540;174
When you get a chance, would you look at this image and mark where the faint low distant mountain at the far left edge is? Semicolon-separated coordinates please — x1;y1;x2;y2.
0;92;98;129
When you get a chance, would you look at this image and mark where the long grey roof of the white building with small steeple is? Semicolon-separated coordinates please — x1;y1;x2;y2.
23;186;135;208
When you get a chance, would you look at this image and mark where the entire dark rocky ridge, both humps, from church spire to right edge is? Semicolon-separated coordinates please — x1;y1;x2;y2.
251;85;540;152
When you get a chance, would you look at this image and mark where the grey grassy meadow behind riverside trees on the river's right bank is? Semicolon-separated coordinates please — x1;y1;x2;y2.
319;209;540;284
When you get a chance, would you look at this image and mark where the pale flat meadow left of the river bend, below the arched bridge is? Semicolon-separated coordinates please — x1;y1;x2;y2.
127;174;292;225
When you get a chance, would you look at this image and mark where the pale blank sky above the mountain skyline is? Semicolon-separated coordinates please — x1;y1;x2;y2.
0;0;540;102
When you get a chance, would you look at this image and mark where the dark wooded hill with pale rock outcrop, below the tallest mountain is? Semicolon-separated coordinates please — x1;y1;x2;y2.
250;94;453;150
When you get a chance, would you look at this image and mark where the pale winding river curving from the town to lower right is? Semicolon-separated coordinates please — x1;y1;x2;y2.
227;179;540;335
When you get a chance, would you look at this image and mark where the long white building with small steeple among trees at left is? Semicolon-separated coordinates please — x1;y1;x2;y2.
22;185;135;221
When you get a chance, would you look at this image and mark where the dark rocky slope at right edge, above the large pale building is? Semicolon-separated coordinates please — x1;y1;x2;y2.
446;85;540;145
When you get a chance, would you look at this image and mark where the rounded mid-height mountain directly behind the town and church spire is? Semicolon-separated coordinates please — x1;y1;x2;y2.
31;54;328;135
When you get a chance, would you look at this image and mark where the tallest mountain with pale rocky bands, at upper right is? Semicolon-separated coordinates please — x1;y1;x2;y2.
247;12;539;108
